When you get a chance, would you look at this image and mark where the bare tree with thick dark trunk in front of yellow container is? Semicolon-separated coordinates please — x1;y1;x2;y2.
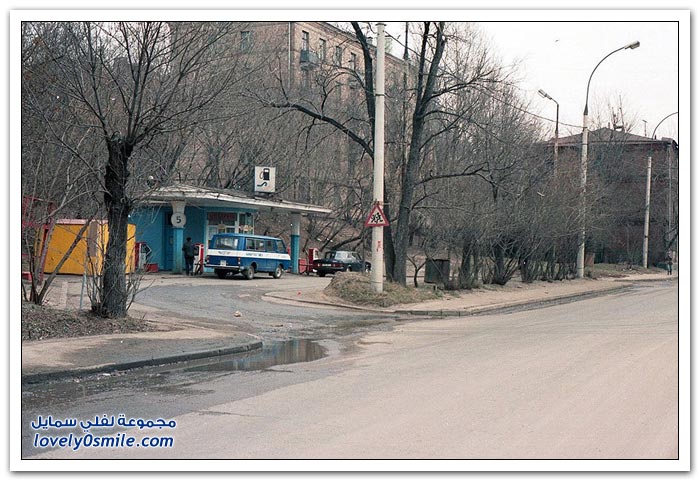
23;22;243;317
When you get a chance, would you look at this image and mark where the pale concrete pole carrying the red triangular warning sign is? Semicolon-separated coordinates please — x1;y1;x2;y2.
370;22;385;293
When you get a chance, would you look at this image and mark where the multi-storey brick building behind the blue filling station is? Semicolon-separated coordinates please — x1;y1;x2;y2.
173;22;408;206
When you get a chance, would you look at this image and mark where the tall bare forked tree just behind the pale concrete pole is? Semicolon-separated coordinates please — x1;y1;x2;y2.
259;22;501;285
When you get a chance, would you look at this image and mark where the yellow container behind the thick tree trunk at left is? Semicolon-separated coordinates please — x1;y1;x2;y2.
44;219;136;275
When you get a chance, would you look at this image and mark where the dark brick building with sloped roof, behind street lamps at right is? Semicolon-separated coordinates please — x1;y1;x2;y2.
547;128;678;266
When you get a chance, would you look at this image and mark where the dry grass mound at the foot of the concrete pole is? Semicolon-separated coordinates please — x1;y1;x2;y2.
324;272;442;307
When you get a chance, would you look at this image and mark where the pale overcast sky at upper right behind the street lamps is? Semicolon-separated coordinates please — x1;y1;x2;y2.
481;21;679;138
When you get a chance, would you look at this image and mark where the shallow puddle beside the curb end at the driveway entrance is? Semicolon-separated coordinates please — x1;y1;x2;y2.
183;339;326;372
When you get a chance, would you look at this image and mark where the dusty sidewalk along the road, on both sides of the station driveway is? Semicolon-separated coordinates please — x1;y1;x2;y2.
22;274;678;383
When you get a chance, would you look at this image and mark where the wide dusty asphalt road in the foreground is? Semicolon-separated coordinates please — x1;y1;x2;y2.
23;283;678;459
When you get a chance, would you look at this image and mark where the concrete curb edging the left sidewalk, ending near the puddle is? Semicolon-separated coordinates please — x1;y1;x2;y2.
22;341;263;384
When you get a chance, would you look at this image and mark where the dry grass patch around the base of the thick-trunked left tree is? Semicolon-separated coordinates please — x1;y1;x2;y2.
22;302;156;341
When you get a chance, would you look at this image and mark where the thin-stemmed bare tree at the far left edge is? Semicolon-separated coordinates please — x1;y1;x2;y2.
21;23;99;304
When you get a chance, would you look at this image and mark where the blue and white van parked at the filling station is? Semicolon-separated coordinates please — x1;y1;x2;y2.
204;234;291;279
